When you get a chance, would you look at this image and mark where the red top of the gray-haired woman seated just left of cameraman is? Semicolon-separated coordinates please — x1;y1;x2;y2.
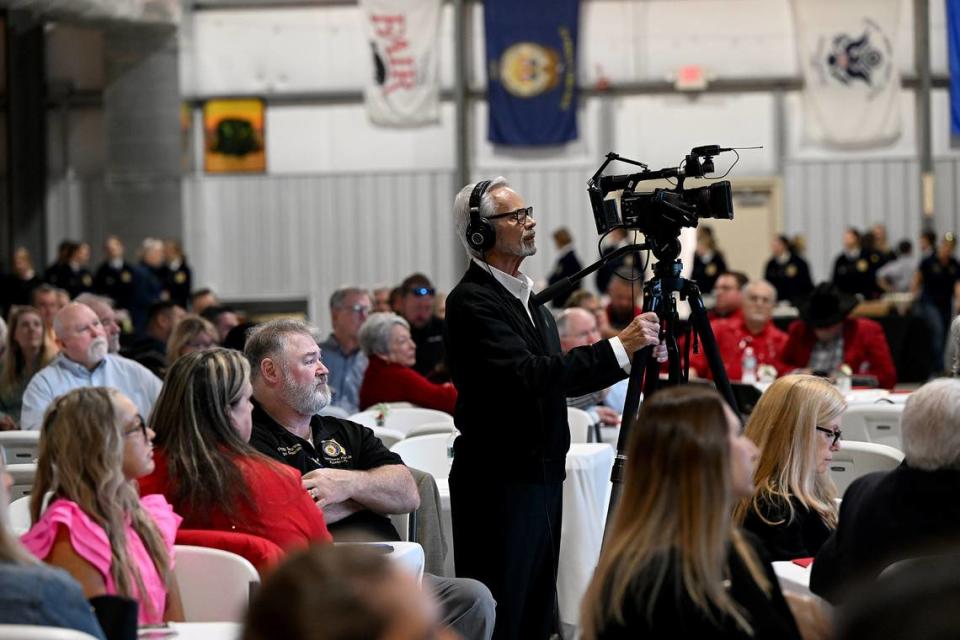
360;356;457;415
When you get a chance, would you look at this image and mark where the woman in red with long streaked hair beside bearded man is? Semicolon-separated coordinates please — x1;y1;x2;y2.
140;349;331;549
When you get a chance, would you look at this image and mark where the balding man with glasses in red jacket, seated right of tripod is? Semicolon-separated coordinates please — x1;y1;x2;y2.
690;280;787;380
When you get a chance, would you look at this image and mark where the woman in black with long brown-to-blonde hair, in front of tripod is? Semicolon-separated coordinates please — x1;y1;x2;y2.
581;384;800;640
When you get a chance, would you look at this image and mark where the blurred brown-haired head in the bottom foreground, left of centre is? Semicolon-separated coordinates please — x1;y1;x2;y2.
242;546;460;640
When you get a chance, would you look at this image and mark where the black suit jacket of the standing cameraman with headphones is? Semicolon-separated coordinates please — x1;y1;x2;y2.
444;262;626;482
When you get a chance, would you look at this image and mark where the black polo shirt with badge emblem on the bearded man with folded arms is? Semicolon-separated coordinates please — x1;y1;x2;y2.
250;400;403;540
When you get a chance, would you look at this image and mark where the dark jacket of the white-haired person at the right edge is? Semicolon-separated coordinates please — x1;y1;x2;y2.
810;463;960;603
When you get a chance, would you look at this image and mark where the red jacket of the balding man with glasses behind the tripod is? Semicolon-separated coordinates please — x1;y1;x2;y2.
690;313;787;381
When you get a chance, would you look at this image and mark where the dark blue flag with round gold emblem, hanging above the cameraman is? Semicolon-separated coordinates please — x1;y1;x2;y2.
483;0;580;145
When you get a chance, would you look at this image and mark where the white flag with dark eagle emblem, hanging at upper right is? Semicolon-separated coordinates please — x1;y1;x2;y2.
792;0;901;149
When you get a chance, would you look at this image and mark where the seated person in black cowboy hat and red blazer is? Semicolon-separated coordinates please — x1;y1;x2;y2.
780;282;897;389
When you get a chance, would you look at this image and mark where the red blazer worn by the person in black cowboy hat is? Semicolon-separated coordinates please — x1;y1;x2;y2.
779;318;897;389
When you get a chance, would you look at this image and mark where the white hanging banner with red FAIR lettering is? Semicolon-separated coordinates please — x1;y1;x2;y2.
360;0;441;126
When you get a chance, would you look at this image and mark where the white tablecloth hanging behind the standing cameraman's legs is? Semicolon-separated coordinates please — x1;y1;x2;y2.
437;444;615;625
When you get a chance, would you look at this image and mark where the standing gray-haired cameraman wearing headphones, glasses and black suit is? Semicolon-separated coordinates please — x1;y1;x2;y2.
444;177;666;640
